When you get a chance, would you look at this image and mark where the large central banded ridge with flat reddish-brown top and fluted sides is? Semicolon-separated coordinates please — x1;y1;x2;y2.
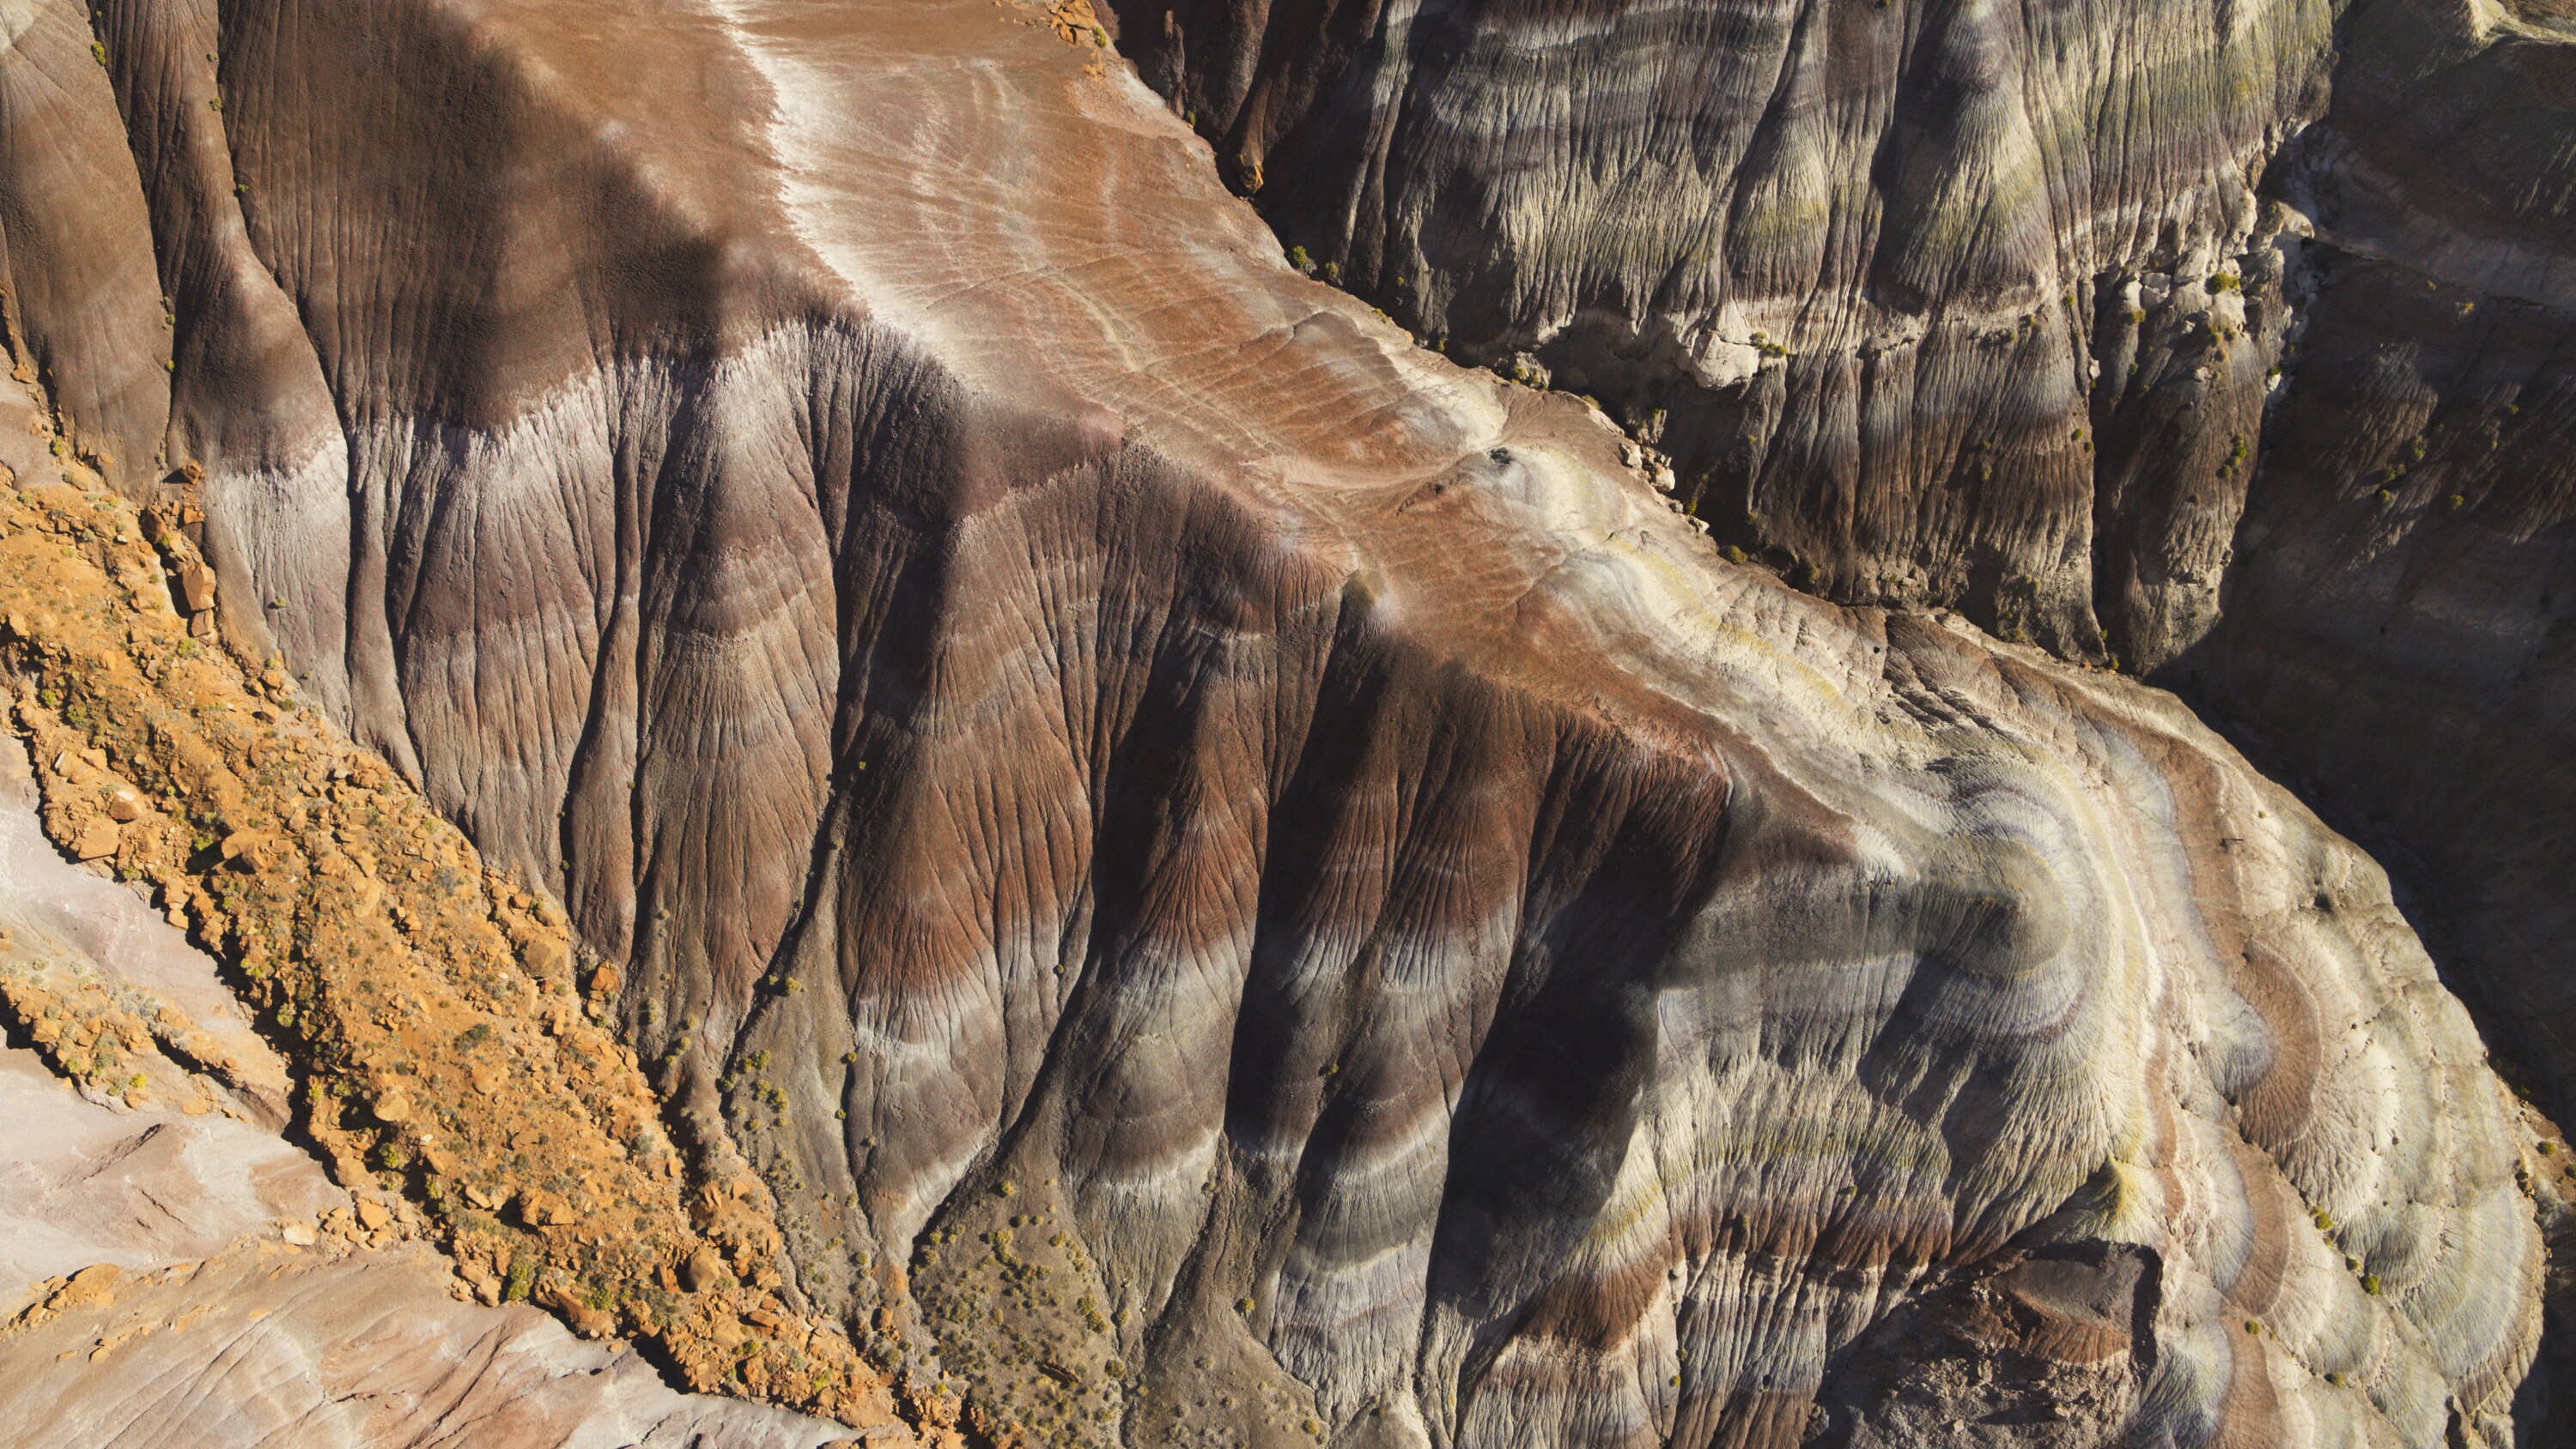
0;0;2555;1446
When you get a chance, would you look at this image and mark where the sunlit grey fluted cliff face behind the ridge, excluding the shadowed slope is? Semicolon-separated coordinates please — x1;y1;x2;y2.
1118;0;2334;664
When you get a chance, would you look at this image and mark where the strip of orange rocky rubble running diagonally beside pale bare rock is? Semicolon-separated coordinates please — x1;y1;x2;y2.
0;474;963;1444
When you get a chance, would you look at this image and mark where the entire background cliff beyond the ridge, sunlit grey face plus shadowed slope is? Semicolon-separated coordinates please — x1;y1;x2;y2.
1118;0;2576;1099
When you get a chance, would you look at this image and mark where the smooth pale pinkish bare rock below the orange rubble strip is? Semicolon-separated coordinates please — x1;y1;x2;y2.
0;720;850;1449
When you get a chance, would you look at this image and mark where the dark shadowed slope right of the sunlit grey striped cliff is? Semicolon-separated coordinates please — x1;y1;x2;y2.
2172;3;2576;1132
